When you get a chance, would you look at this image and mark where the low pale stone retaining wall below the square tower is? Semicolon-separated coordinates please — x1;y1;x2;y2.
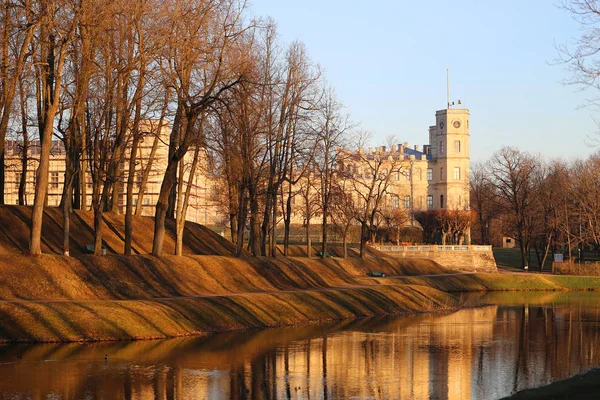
372;245;498;272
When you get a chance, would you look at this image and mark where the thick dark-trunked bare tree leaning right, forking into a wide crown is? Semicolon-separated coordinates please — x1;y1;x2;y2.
152;0;244;256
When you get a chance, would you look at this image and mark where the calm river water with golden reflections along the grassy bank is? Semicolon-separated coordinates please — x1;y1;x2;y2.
0;293;600;400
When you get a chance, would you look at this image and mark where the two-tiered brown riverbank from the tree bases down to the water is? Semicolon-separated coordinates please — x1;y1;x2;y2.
0;255;457;342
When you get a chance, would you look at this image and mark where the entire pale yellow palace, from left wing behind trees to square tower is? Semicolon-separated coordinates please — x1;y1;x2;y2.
5;107;470;231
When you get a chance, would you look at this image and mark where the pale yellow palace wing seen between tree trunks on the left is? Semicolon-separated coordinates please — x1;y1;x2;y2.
4;120;222;225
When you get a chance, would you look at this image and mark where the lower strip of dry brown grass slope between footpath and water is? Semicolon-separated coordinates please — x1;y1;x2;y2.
0;286;456;342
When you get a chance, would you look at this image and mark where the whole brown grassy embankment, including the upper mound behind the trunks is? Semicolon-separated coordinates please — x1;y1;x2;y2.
0;206;600;341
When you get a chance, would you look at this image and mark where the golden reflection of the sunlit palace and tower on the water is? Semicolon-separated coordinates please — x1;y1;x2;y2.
268;307;496;400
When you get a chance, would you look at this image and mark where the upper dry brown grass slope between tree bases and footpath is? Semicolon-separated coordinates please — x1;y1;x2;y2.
0;255;446;300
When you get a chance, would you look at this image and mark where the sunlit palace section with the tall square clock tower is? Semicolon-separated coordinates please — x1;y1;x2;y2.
343;104;470;213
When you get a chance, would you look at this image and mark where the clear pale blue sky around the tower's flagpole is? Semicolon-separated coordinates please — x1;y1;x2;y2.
250;0;600;161
